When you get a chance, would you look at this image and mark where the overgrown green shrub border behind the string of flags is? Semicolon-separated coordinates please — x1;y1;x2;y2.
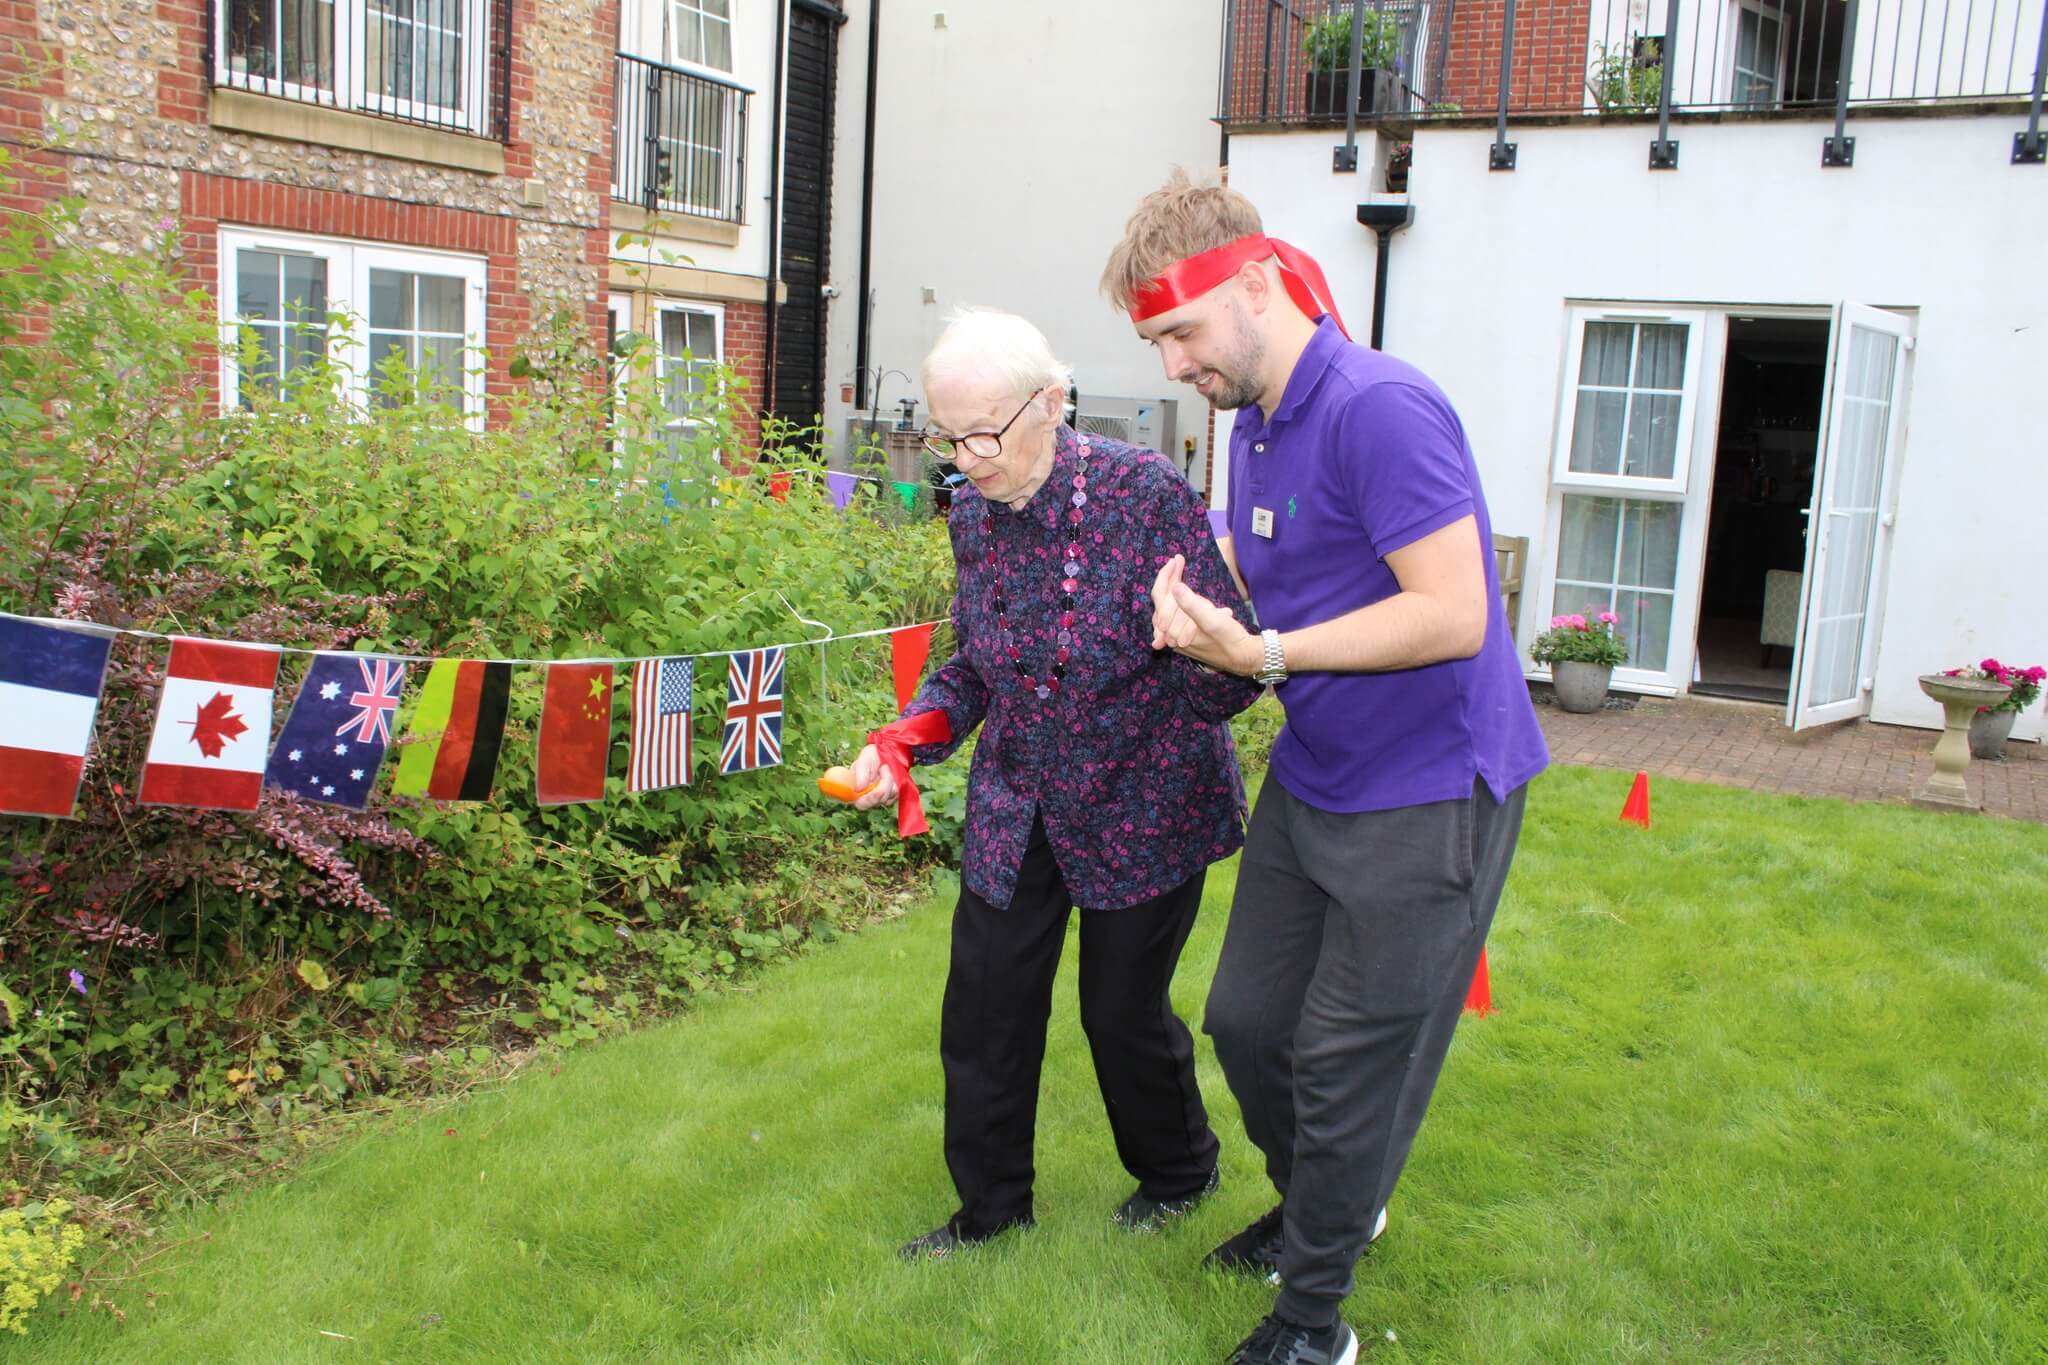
0;164;965;1219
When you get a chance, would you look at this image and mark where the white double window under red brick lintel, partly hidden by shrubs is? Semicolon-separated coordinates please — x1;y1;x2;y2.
221;227;483;415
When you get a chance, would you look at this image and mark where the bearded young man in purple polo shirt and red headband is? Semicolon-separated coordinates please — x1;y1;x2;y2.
1102;174;1548;1365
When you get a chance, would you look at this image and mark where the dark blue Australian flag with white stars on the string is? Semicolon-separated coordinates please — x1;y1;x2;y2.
266;655;406;810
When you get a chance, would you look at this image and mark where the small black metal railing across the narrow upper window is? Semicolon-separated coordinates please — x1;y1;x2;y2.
612;53;752;223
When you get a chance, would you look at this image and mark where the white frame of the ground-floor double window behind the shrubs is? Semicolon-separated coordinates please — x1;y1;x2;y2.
219;227;487;426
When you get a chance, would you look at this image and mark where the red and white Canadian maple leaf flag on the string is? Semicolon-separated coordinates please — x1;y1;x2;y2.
137;636;279;810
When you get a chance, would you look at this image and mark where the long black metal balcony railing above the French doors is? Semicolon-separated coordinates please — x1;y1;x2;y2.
1217;0;2048;129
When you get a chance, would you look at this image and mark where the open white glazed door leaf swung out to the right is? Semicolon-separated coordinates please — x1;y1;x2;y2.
1786;303;1913;731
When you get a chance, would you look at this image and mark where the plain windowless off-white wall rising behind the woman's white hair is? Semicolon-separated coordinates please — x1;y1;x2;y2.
825;0;1228;485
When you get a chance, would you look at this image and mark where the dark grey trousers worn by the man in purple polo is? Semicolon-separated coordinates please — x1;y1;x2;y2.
1202;780;1528;1326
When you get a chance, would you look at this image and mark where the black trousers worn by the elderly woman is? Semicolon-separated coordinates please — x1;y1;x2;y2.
938;821;1217;1236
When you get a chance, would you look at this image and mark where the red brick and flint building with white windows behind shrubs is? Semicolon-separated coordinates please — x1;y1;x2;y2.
0;0;836;442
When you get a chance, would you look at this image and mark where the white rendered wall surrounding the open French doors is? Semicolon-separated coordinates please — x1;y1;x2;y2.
1219;117;2048;739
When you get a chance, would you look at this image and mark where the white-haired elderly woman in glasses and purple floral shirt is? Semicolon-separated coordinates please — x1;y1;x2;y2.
854;311;1260;1259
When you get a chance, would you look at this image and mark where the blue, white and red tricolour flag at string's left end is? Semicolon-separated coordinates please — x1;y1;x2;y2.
0;616;113;821
